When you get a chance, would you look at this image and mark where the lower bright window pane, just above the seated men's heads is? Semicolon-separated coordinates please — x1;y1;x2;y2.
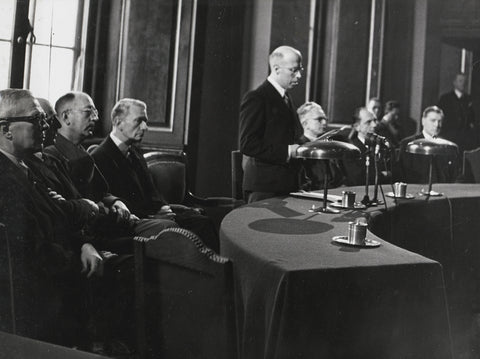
30;45;73;103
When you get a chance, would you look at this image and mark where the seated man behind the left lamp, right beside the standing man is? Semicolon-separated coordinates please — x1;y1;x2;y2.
297;102;344;191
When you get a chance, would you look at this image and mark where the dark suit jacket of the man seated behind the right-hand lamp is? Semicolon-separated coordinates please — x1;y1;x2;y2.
396;133;458;183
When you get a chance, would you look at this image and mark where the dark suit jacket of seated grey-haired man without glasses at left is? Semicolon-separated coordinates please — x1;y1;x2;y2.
92;136;167;217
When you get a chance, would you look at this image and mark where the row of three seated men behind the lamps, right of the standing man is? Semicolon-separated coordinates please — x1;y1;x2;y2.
292;102;460;194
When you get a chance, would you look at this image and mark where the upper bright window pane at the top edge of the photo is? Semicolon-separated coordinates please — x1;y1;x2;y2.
34;0;78;47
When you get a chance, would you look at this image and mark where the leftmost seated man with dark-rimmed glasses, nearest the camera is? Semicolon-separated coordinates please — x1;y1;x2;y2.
0;89;104;345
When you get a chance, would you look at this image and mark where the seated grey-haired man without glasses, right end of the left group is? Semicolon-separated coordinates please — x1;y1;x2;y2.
92;99;219;252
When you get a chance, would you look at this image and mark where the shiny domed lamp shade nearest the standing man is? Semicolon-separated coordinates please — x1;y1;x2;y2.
295;140;360;160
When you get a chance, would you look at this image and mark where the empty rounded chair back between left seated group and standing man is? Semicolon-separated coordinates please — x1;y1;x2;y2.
143;150;187;203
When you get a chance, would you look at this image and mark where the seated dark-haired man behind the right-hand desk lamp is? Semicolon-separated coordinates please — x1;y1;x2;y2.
396;106;458;183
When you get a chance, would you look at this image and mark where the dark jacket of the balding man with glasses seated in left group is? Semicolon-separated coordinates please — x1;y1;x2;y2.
44;134;118;207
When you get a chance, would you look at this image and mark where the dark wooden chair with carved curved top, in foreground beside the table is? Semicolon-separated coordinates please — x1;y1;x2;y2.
135;228;236;359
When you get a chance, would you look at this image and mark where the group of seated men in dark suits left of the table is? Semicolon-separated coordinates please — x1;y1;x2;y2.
0;89;219;354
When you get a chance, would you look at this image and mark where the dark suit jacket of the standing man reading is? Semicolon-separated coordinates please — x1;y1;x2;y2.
240;81;303;193
